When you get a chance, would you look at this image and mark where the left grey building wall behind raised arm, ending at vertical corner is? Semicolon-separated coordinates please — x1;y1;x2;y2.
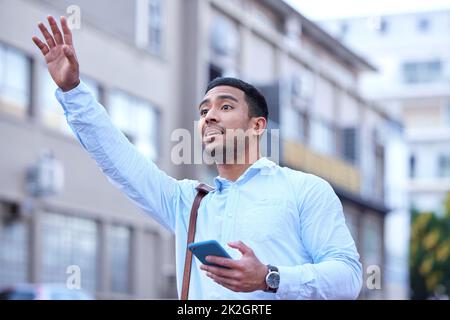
0;1;185;298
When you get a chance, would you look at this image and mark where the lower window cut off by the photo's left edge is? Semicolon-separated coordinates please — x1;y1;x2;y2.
0;203;29;286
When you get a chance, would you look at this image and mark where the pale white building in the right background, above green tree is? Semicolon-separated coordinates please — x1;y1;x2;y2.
320;10;450;300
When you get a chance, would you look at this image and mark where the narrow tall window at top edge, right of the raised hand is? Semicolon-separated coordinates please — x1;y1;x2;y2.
148;0;163;54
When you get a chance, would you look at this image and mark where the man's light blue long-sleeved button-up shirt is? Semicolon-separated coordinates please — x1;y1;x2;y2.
56;83;362;299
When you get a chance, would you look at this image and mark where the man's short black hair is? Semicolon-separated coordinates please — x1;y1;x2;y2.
205;77;269;120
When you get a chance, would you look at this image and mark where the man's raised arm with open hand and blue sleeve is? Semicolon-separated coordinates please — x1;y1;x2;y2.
32;16;197;231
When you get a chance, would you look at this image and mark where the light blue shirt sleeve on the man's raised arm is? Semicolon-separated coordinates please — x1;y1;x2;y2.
55;82;195;232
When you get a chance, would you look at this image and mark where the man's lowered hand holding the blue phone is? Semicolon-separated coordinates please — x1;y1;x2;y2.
200;241;268;292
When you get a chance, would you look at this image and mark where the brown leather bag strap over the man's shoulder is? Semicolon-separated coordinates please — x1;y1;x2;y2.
181;183;214;300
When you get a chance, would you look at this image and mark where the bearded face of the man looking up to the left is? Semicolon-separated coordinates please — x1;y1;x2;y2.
198;86;253;161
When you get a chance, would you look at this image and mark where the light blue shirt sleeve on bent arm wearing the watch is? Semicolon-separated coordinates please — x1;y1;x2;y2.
276;178;362;299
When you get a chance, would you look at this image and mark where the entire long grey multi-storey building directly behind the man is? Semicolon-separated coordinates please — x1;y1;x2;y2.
0;0;397;299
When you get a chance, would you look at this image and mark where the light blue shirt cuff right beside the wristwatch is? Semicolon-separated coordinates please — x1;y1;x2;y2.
275;265;314;300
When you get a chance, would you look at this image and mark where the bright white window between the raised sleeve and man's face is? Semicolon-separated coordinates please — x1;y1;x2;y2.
109;90;158;160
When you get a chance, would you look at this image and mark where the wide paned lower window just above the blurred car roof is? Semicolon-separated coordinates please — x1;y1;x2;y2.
41;213;98;292
